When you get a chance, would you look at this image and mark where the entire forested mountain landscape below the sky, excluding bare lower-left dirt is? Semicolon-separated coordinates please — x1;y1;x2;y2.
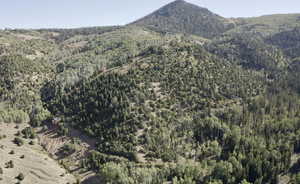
0;0;300;184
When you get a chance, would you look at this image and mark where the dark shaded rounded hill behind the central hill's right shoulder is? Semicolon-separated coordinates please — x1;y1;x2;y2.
205;33;289;71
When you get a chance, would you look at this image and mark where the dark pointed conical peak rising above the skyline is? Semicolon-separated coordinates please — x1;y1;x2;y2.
132;0;234;38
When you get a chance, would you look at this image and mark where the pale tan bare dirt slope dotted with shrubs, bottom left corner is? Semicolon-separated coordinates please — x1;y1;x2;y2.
0;123;75;184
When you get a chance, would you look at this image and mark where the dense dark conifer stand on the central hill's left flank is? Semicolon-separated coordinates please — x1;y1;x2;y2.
44;74;136;154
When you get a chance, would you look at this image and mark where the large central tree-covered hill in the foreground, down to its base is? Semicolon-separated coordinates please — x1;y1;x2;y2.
44;37;299;183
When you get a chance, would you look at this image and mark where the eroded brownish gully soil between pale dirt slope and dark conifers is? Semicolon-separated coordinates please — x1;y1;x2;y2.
37;123;100;184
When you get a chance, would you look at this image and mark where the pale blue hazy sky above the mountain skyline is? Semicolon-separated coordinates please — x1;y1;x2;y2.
0;0;300;28
